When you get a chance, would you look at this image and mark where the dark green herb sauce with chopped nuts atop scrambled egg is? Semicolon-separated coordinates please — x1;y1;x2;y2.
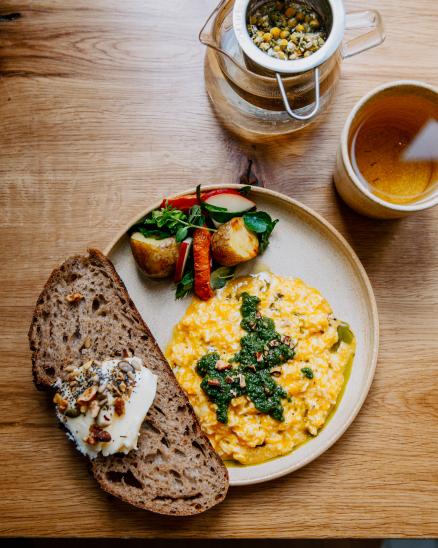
196;292;295;424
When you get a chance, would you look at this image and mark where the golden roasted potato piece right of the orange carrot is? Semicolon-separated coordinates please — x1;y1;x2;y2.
211;217;259;266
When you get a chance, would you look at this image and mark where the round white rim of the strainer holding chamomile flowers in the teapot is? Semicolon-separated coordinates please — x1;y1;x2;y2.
233;0;345;74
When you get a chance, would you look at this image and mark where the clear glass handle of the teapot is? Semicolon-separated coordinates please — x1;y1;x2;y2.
341;10;386;59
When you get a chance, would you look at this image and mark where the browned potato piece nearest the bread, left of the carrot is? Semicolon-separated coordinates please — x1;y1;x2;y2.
131;232;181;278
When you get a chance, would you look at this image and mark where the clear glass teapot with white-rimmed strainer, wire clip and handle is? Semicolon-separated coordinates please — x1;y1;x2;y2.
199;0;385;133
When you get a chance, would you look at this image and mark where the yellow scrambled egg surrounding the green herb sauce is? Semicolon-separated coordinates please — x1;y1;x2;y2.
166;272;356;464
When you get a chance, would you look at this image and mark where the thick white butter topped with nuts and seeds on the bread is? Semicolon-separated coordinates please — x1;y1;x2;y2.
55;358;158;459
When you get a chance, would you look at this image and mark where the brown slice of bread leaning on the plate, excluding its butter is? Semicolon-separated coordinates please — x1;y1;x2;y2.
29;249;228;516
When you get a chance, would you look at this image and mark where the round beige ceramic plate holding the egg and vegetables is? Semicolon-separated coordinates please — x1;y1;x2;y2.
106;185;379;485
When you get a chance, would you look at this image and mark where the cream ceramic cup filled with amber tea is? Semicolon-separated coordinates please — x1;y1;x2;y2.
334;80;438;219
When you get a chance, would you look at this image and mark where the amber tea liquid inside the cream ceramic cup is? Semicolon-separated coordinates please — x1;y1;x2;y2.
349;95;438;204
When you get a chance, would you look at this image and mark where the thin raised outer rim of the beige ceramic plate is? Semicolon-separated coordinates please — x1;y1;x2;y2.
104;184;379;486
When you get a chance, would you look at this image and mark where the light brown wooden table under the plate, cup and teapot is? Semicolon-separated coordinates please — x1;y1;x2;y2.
0;0;438;538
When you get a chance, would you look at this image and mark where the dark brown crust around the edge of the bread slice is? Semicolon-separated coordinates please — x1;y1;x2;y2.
28;249;229;516
